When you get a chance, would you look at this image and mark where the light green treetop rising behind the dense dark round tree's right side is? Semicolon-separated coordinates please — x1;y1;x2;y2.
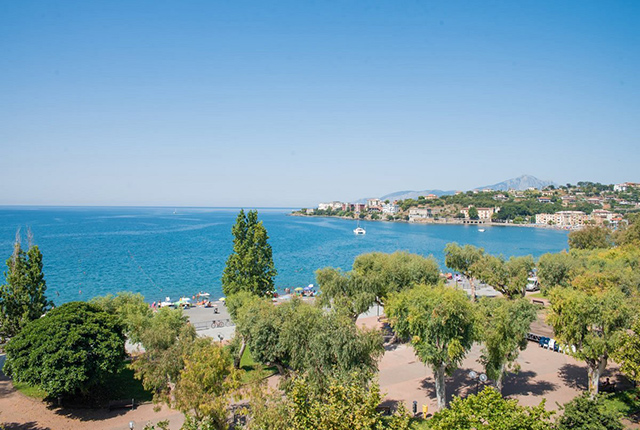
90;291;152;343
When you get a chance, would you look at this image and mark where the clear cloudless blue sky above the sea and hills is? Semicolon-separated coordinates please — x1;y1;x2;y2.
0;0;640;206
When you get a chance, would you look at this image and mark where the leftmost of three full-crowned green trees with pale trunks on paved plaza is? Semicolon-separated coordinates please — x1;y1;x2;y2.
385;286;478;409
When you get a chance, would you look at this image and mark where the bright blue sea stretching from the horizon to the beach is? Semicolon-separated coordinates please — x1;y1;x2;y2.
0;207;567;304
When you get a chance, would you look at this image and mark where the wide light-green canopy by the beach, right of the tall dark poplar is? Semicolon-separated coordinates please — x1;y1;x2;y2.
316;252;440;319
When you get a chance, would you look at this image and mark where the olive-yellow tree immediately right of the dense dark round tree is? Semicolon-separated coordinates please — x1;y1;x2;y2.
131;308;196;405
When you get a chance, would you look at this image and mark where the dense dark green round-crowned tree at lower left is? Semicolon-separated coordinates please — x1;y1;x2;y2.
4;302;125;397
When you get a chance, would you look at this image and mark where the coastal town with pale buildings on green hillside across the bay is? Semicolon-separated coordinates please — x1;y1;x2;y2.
294;182;640;229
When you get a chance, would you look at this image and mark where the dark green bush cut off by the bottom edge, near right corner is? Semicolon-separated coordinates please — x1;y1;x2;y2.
557;394;624;430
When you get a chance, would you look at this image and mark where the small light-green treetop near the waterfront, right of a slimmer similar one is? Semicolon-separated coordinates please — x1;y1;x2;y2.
474;255;535;299
